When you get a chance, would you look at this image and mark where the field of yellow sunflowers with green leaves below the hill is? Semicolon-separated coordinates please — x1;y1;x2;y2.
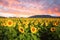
0;18;60;40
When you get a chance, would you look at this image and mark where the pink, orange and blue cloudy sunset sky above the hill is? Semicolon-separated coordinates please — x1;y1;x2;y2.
0;0;60;17
